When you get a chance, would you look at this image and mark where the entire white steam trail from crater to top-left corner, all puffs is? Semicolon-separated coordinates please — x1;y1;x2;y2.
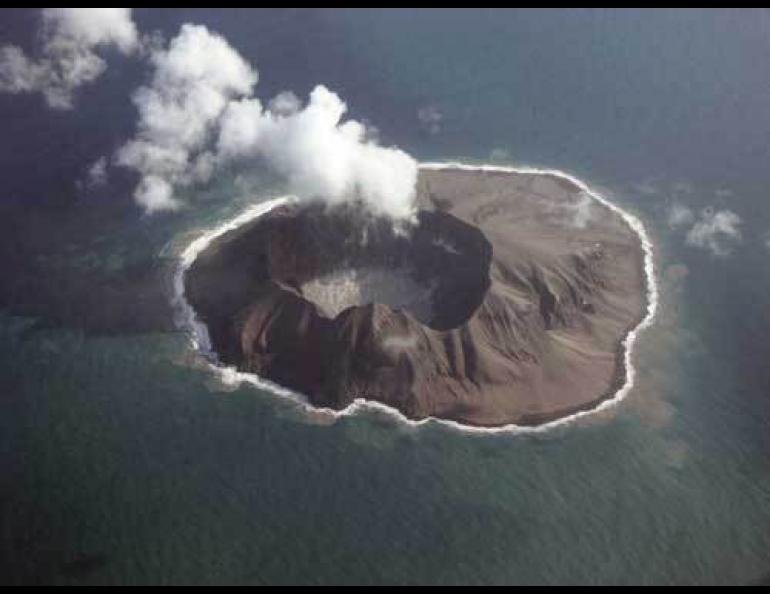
0;8;417;219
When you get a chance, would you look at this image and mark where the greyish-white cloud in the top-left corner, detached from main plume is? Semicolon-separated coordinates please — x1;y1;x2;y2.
0;8;139;109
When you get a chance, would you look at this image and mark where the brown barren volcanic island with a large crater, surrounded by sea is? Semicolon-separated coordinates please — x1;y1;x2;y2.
184;168;649;427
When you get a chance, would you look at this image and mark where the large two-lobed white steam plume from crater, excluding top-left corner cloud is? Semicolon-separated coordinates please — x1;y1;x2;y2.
117;25;417;218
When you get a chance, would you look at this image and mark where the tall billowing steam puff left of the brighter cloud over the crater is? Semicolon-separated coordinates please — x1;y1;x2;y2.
116;25;257;212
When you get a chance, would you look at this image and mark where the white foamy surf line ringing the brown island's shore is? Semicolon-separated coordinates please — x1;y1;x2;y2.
166;161;658;434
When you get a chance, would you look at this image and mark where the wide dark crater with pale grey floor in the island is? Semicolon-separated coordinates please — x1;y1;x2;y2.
265;205;492;330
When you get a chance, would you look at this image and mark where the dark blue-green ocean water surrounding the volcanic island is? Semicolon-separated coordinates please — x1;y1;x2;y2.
0;10;770;585
